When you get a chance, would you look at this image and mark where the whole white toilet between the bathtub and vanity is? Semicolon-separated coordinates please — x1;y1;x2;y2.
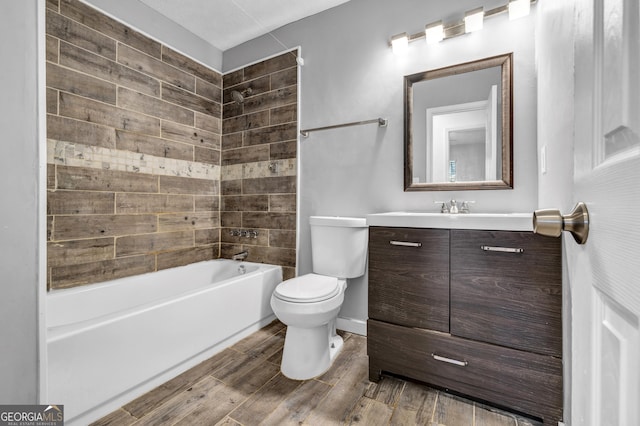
271;216;369;380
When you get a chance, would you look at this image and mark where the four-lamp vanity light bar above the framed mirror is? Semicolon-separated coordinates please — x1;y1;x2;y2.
389;0;538;53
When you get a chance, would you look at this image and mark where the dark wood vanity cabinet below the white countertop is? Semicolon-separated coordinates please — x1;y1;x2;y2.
367;227;562;425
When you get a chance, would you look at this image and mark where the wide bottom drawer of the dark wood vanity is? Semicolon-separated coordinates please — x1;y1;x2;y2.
367;320;562;424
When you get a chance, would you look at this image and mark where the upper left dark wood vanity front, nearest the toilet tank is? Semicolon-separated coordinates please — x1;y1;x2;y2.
369;227;449;331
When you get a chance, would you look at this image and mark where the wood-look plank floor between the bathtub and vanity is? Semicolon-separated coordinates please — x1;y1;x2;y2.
93;321;541;426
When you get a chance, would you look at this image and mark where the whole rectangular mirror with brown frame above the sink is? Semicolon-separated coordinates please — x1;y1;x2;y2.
404;53;513;191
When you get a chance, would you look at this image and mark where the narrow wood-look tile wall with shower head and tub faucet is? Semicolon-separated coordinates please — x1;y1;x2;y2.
220;51;298;279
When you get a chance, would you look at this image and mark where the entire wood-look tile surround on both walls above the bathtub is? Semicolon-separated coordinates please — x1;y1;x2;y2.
46;0;297;289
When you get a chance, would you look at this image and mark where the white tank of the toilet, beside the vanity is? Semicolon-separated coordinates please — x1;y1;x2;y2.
309;216;369;278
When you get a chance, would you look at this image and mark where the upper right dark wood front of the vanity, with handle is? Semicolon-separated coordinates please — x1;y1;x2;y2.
450;229;562;357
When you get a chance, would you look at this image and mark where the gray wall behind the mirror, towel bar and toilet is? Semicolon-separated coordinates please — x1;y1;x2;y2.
223;0;538;326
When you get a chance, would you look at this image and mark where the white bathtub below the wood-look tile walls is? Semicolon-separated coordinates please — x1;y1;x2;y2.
47;260;282;425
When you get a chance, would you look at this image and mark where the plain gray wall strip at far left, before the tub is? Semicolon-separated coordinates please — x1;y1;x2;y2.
0;0;46;404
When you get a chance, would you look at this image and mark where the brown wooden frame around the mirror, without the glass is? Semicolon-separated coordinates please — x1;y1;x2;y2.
404;53;513;191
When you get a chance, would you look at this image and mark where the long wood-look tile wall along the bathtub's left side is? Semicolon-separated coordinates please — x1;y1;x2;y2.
46;0;222;289
